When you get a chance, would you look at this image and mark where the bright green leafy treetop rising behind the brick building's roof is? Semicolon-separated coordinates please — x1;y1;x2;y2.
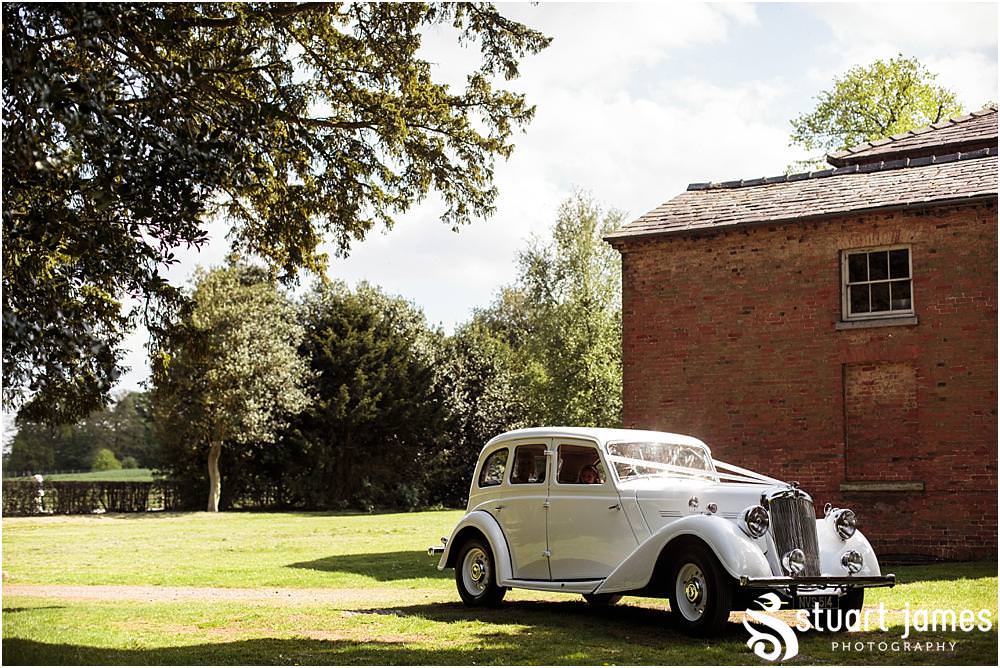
791;54;962;167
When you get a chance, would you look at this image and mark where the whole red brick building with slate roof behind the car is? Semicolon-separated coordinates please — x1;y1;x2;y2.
608;108;997;558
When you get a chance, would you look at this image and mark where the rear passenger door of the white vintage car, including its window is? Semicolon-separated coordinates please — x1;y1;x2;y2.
495;438;551;580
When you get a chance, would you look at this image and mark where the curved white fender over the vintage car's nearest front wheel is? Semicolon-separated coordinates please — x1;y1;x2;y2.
594;515;772;594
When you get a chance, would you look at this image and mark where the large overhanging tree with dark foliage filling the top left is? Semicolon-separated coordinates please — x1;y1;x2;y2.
2;3;549;422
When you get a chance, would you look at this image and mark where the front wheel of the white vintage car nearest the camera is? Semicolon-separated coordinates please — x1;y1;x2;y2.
668;543;733;635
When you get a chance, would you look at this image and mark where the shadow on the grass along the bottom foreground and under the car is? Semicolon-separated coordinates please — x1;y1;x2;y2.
3;599;997;665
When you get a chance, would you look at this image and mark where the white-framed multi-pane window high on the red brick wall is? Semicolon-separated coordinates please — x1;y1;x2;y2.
840;246;914;320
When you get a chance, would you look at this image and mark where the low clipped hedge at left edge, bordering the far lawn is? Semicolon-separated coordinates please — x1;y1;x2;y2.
3;480;177;516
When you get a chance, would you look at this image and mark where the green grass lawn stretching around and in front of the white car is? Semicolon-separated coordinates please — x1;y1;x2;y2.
3;511;997;665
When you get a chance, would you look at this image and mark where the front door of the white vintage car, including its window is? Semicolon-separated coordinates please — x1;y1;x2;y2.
548;438;638;581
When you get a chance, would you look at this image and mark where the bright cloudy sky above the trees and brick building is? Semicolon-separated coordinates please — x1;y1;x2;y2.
118;2;997;390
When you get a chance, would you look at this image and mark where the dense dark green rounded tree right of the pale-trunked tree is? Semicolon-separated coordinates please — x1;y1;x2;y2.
290;284;450;508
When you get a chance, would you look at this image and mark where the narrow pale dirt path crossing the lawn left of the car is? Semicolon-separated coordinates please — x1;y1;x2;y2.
3;583;447;607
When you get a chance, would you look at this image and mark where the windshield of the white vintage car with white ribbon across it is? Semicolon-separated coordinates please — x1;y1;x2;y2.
608;442;715;480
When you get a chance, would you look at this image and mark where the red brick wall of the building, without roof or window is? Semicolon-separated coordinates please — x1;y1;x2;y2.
616;203;997;558
